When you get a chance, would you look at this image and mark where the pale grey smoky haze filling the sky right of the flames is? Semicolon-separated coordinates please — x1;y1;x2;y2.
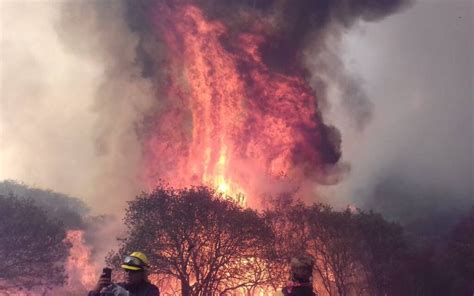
330;0;474;227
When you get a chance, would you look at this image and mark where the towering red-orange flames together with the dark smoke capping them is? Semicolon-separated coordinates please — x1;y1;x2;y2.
125;0;414;207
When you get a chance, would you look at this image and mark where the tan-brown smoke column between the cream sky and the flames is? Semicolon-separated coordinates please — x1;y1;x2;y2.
55;1;155;210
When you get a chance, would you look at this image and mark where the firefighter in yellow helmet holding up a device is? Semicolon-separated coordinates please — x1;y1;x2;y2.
88;251;160;296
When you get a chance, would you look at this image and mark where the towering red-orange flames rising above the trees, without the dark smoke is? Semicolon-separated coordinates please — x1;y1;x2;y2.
145;1;339;205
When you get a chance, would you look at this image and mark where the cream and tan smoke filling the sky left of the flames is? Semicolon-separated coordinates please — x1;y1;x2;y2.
0;1;156;213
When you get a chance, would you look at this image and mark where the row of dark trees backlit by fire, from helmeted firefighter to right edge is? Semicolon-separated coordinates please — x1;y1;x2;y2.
109;187;474;296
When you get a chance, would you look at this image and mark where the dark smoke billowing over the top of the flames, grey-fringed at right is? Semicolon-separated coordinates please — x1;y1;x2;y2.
124;0;413;130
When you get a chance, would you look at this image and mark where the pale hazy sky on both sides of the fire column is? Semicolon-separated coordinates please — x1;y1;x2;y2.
0;0;474;210
